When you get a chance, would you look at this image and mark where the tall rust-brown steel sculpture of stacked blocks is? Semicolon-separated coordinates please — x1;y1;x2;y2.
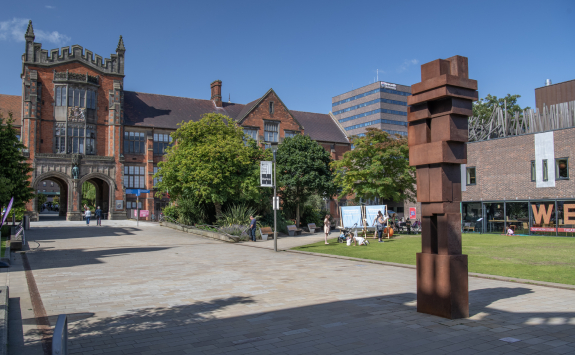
407;56;478;319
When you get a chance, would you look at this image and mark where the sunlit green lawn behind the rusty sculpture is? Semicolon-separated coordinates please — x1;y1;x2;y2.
294;234;575;285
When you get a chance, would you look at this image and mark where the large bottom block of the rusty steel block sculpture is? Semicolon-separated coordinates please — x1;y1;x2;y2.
417;253;469;319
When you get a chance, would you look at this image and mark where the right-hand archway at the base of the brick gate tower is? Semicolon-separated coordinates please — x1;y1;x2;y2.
78;173;115;219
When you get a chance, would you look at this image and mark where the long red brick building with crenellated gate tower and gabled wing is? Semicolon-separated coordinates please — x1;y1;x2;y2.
0;22;350;220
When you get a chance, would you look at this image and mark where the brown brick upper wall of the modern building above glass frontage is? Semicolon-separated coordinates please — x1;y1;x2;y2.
463;128;575;201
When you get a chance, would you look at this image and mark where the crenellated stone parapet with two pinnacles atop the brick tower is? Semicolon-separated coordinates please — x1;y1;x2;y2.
22;21;126;76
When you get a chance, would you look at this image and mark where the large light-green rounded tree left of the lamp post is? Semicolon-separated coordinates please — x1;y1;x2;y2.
154;113;271;216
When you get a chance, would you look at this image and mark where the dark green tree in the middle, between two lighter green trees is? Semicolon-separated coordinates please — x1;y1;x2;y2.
276;134;336;226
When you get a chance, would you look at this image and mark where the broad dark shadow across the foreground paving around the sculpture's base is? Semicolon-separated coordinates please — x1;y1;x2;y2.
20;287;575;354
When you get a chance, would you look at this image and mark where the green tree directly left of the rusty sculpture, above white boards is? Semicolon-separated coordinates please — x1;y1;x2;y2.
332;128;416;202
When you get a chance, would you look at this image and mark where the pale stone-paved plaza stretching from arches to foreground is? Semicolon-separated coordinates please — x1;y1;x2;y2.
7;220;575;355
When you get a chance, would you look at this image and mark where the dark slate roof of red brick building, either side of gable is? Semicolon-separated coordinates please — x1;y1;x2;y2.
124;91;349;143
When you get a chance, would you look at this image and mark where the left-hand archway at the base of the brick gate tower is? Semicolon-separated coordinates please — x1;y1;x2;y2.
32;171;71;219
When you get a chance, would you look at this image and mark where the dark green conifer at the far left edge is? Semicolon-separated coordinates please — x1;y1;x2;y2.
0;112;34;208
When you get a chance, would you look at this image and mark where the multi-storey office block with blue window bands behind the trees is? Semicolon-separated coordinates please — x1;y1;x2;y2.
331;81;411;137
